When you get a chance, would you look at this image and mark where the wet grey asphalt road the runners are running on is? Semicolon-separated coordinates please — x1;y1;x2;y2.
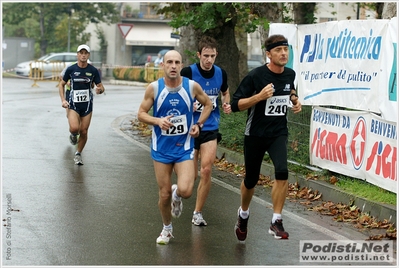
2;78;396;266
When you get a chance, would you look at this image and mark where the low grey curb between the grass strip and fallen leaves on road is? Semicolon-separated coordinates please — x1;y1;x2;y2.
216;146;396;224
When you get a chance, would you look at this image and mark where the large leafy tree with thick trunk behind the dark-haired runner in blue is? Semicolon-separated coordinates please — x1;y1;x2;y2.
158;2;282;91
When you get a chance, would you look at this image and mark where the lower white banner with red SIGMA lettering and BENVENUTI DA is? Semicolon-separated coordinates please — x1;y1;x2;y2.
309;107;398;193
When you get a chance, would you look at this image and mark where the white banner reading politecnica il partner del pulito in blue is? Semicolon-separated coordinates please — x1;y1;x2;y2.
298;20;388;113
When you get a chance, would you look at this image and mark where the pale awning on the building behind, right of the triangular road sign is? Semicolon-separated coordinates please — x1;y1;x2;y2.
125;24;178;47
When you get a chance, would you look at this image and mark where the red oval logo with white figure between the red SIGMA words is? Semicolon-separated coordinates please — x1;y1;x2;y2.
350;116;367;170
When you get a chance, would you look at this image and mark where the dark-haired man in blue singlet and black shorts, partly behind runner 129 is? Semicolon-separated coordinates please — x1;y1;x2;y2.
180;35;231;226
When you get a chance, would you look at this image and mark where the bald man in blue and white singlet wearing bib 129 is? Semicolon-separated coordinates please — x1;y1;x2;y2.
137;50;212;245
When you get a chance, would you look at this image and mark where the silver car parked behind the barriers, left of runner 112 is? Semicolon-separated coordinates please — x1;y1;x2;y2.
15;52;77;77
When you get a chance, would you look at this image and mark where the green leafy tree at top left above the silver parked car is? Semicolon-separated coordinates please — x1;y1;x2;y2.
2;2;120;55
